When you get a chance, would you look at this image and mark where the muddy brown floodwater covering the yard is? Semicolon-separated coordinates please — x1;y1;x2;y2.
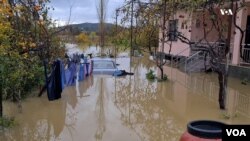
0;57;250;141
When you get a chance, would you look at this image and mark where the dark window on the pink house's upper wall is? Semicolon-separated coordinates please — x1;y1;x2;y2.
168;20;178;41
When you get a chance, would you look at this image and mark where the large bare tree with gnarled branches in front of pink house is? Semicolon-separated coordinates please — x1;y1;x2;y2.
178;0;250;109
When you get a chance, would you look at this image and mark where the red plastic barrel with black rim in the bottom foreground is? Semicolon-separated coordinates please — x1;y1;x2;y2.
180;120;224;141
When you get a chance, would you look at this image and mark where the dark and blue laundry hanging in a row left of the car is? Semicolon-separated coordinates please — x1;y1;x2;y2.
42;56;93;101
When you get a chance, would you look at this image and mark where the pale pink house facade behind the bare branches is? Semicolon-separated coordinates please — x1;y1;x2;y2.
159;0;250;66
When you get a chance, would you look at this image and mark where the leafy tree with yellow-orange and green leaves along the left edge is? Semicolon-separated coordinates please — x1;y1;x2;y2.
0;1;65;103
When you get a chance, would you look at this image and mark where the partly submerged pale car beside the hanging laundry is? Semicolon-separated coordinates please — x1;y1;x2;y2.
92;58;118;75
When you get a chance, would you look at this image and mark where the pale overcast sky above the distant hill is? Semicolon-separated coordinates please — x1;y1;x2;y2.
50;0;124;24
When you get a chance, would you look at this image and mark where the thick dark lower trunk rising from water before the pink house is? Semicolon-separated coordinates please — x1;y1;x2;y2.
218;72;227;110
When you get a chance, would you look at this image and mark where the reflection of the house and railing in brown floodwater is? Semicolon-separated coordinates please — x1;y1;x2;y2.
165;67;250;118
